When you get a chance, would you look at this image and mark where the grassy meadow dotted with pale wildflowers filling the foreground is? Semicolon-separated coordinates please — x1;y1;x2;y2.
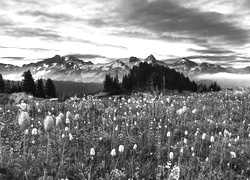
0;89;250;180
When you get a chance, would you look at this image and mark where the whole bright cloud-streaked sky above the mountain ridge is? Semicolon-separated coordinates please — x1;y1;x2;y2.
0;0;250;67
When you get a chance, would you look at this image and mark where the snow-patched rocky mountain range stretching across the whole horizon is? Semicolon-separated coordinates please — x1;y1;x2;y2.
0;55;250;87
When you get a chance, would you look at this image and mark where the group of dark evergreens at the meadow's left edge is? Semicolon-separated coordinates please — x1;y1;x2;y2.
0;70;57;98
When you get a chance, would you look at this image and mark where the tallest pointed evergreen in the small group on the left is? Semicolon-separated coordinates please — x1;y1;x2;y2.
22;70;36;95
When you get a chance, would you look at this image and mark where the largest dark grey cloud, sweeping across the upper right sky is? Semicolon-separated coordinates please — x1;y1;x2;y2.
113;0;249;45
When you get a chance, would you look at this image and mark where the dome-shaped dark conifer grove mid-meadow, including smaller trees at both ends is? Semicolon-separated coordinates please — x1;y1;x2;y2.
103;62;220;95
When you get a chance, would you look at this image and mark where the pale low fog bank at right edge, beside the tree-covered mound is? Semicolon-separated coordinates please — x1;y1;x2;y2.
194;73;250;88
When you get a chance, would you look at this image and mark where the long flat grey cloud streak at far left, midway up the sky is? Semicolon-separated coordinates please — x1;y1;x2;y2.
5;27;62;41
